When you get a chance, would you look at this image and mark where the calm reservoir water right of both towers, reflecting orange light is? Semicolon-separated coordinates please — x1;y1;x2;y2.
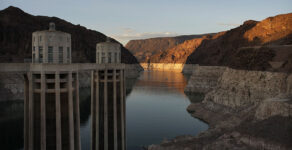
126;71;208;150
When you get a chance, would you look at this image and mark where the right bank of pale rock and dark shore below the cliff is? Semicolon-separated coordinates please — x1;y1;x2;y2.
147;66;292;150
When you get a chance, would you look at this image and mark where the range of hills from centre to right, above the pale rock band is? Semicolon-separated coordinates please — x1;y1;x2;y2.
126;13;292;72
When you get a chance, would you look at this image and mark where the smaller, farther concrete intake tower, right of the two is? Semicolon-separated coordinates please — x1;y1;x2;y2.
91;39;126;150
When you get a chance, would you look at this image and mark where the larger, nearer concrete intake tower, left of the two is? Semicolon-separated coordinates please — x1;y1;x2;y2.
24;23;80;150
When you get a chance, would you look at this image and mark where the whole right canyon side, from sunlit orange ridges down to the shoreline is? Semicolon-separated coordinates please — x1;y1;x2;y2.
148;13;292;150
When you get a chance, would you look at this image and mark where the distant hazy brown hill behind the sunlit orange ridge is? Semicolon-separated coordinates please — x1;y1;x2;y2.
125;35;209;62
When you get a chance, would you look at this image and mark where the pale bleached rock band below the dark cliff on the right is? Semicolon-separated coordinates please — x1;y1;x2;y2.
185;66;292;119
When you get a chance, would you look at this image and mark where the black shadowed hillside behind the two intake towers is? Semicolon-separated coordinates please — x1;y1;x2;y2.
0;6;138;64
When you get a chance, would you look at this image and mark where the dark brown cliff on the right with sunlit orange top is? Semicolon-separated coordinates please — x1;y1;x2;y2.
186;13;292;72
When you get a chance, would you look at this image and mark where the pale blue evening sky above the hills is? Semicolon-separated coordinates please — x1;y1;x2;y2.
0;0;292;44
